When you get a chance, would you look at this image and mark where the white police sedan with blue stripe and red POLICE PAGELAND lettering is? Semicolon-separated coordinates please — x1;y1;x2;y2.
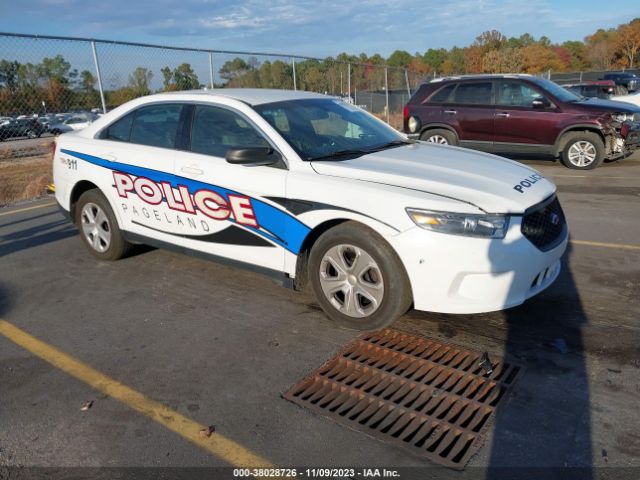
54;89;568;329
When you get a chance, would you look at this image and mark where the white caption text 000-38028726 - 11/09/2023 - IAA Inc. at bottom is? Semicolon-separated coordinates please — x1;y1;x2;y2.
233;468;400;478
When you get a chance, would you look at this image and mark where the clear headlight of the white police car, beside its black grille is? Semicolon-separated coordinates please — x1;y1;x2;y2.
406;208;509;238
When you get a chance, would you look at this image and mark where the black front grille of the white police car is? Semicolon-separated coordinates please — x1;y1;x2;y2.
521;197;566;251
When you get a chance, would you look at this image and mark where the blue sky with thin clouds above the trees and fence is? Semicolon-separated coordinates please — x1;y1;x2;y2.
0;0;640;57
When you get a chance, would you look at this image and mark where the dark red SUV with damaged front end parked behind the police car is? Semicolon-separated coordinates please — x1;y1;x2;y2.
404;75;640;170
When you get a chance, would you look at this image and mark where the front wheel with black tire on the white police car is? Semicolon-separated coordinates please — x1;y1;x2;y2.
308;221;412;330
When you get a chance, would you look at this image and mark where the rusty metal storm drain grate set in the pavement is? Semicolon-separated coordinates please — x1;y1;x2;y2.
284;329;523;469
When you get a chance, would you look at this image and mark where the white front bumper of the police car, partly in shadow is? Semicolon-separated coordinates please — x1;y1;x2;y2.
389;217;568;313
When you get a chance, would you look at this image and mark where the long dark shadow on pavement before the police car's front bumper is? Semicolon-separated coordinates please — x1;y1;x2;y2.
486;244;593;480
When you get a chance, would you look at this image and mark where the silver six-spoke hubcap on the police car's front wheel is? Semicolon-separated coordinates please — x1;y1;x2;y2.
320;245;384;318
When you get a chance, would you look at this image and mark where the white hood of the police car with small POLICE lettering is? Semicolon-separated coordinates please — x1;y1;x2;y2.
312;143;556;213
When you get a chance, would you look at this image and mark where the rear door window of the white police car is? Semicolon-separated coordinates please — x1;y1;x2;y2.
129;104;182;148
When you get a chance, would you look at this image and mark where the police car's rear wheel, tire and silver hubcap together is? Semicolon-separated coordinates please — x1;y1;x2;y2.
75;190;131;260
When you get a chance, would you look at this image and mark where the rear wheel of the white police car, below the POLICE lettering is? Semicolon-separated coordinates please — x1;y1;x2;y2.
74;189;132;261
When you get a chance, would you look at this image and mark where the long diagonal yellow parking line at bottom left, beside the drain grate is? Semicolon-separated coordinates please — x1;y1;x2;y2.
0;320;272;468
